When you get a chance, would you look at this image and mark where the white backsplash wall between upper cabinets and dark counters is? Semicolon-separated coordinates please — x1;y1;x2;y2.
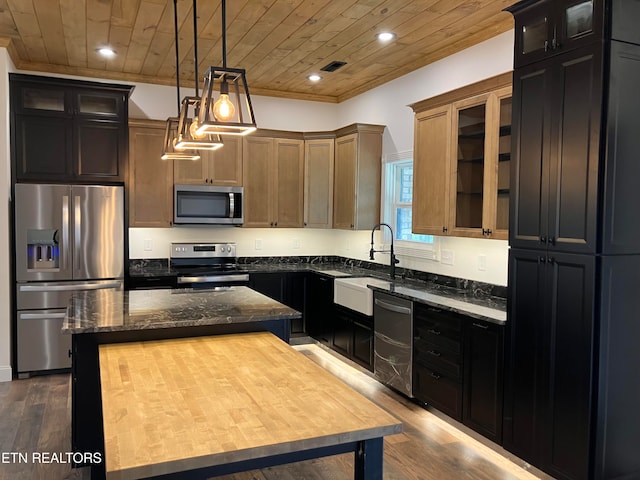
129;227;508;285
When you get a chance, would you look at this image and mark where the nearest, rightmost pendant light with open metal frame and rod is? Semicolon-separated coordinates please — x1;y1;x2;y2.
197;0;257;135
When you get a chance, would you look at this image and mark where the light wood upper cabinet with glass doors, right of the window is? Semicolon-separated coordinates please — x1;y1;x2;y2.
412;73;511;239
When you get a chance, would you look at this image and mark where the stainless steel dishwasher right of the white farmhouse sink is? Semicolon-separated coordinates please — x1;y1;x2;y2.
373;292;413;397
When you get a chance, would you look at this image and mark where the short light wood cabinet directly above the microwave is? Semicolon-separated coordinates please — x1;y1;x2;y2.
174;135;242;186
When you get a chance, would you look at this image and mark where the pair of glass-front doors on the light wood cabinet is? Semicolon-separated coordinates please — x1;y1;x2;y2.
449;87;511;239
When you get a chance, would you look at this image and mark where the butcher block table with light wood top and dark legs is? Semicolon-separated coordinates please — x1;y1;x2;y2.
99;332;402;480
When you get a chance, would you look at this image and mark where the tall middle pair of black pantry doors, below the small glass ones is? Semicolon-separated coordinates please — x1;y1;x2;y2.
509;44;602;253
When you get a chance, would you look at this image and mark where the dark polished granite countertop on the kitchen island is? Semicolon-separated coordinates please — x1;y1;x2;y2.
62;287;301;333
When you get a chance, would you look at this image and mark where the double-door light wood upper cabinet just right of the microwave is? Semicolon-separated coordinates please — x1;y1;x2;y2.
242;135;304;228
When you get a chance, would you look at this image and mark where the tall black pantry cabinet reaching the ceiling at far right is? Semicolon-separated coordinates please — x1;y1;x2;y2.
503;0;640;479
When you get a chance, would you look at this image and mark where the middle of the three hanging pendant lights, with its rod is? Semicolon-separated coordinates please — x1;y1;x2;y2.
174;0;222;150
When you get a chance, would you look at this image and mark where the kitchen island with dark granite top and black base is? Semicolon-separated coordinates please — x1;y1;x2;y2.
63;287;301;470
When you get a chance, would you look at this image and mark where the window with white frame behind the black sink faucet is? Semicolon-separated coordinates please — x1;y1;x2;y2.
383;152;434;244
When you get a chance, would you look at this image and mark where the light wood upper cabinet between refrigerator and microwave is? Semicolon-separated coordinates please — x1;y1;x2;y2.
127;120;173;227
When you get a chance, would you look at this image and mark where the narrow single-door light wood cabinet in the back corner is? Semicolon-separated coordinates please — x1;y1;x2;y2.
304;138;335;228
